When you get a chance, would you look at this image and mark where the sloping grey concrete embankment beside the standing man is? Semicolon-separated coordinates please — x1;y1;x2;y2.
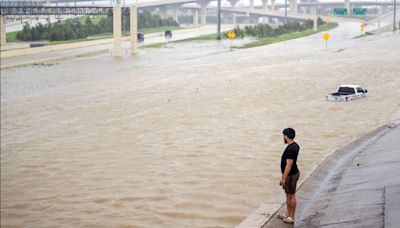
263;123;400;228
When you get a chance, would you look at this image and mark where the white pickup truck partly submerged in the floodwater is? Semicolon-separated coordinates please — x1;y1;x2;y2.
326;85;368;101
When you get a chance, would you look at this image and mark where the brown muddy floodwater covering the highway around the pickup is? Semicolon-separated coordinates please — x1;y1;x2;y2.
1;23;400;227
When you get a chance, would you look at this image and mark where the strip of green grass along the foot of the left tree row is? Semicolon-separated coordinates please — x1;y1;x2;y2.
7;27;183;45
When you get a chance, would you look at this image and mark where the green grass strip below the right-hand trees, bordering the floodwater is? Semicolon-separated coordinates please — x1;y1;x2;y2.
238;23;338;48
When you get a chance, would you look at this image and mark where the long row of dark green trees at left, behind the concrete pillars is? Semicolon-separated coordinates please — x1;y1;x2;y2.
16;12;178;41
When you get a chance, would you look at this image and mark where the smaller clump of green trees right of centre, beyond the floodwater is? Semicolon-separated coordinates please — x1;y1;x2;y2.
233;18;325;38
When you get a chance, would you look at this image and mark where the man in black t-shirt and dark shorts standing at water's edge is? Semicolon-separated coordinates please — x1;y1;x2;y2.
278;128;300;224
